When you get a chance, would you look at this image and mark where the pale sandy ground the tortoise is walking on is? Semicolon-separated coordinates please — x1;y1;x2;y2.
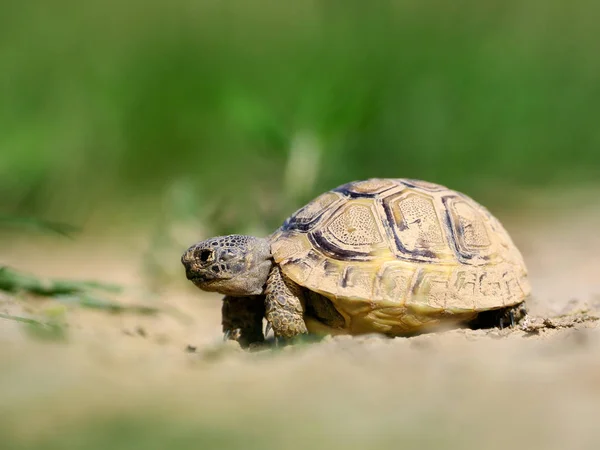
0;201;600;449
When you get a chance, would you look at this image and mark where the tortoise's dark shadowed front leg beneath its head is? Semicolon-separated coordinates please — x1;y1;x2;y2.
221;295;265;348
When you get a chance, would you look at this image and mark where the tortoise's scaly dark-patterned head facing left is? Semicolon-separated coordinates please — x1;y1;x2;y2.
181;234;273;296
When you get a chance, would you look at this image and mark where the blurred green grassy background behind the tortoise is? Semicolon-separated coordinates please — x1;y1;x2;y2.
0;0;600;232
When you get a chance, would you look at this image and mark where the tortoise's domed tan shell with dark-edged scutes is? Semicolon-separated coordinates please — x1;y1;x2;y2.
271;179;530;332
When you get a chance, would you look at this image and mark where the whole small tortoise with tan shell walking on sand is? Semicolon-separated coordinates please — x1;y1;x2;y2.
182;178;531;347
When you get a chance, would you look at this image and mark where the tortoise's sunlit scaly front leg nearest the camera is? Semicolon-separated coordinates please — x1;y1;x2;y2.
265;266;308;338
